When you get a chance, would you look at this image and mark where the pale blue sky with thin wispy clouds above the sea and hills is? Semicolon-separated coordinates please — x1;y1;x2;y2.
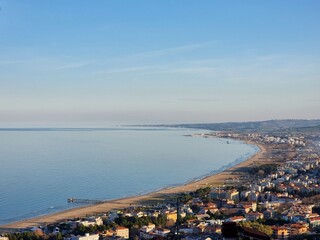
0;0;320;127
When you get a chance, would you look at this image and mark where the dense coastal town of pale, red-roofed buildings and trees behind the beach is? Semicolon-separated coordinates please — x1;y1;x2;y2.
0;129;320;240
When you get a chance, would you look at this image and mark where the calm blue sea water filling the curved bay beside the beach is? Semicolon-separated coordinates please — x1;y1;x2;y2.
0;128;258;225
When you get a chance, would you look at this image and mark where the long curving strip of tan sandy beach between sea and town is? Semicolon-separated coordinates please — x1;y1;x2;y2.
0;142;270;229
